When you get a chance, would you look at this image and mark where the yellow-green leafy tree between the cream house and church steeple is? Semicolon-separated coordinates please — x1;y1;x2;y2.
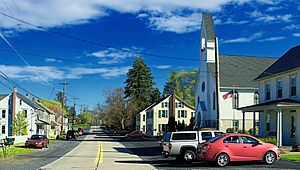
163;69;198;106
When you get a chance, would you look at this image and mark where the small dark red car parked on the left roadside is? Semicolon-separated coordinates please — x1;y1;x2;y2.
25;135;49;148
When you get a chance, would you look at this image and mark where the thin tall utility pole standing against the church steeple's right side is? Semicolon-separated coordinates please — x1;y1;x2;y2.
214;37;220;130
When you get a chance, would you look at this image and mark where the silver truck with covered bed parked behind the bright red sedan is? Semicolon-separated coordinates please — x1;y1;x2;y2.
161;130;224;162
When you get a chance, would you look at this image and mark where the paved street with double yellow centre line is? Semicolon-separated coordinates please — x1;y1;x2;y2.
40;128;300;170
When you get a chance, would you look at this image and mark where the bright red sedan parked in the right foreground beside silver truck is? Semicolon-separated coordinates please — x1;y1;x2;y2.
197;134;280;167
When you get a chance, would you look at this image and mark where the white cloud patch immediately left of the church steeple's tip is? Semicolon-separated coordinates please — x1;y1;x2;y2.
149;13;202;33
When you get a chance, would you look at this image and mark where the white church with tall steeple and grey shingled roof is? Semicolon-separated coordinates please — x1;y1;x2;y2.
195;14;276;131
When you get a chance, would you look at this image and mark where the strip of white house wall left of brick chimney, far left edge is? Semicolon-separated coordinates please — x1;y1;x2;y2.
0;94;10;139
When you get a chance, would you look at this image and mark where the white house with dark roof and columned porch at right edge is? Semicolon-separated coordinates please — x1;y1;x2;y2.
240;46;300;146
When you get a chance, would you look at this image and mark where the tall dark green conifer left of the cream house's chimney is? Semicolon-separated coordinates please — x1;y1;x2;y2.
125;57;160;110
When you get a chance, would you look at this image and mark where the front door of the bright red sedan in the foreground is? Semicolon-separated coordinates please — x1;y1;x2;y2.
241;135;264;161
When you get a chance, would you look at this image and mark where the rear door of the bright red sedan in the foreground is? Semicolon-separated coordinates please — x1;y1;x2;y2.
223;135;245;161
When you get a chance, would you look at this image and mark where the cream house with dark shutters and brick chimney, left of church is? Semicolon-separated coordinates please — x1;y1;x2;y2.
144;94;195;136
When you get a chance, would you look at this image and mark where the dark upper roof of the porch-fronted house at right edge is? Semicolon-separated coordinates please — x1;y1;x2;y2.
256;45;300;80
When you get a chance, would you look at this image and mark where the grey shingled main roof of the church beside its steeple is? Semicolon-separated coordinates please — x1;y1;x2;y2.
208;55;277;88
